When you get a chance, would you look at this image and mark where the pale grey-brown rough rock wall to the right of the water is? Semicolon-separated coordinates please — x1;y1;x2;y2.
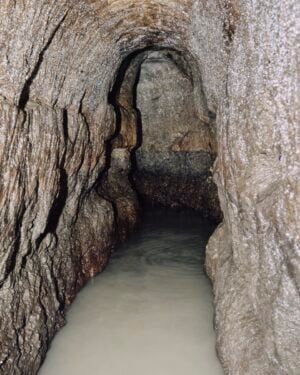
207;1;300;374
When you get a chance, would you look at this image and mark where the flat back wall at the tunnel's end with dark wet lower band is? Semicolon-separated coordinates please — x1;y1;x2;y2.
133;50;221;220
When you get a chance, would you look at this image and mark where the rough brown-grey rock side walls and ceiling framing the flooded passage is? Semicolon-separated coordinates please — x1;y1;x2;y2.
0;0;300;375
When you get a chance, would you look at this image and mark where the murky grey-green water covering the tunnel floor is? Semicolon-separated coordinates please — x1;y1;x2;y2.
40;210;223;375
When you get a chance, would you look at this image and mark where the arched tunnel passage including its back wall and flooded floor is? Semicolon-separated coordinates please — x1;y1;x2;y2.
41;47;223;375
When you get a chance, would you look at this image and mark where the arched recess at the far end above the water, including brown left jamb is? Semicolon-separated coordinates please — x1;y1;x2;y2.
98;47;222;244
